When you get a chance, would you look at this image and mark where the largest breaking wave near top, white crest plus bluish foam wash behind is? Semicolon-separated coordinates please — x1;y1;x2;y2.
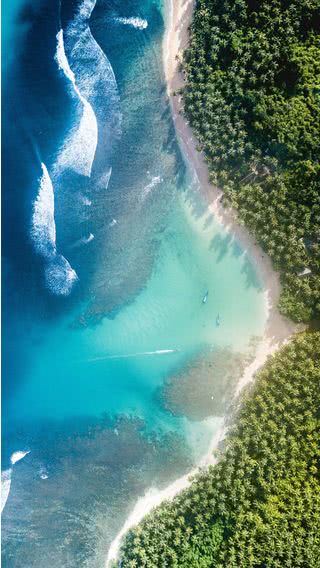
55;0;121;177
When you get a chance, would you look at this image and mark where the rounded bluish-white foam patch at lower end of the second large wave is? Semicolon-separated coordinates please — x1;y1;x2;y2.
45;254;78;296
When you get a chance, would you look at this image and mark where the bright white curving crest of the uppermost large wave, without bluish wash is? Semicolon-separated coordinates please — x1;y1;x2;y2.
55;30;98;177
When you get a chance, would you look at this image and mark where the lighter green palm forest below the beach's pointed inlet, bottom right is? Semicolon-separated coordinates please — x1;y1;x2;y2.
117;332;320;568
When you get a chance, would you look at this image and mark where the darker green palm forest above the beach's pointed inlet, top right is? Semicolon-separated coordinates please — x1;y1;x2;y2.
183;0;320;322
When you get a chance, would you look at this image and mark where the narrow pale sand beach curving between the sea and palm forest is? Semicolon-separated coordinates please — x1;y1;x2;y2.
105;0;299;568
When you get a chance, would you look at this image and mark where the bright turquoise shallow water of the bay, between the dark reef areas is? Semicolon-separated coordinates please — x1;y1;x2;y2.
12;189;264;427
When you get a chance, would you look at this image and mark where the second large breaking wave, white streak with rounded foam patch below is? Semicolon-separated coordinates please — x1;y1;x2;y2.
31;163;78;296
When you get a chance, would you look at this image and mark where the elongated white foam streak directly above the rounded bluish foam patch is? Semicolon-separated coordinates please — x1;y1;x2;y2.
31;163;56;258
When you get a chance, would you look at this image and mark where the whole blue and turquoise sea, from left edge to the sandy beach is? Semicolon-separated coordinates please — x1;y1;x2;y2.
2;0;266;568
